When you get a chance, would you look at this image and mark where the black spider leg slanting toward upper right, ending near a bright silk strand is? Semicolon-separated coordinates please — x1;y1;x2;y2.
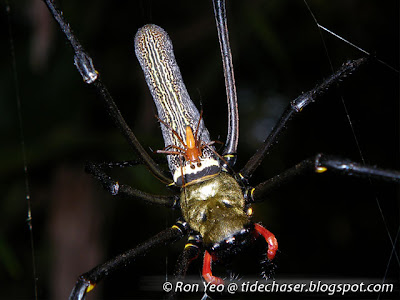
240;58;367;180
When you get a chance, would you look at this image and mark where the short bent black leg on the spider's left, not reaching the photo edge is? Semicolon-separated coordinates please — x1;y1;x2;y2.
85;163;179;208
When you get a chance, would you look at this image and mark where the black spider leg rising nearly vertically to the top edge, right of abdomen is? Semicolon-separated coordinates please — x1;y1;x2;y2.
213;0;239;169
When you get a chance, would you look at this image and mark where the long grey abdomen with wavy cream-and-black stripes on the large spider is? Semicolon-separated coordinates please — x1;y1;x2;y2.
135;24;216;179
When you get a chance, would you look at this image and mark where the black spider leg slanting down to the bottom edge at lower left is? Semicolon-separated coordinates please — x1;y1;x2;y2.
69;222;188;300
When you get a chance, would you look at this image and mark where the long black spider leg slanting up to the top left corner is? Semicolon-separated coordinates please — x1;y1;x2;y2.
43;0;172;184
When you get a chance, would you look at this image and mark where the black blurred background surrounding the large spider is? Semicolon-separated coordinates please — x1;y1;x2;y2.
0;0;400;299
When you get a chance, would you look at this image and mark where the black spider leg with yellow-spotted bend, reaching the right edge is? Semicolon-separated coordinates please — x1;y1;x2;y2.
245;153;400;203
